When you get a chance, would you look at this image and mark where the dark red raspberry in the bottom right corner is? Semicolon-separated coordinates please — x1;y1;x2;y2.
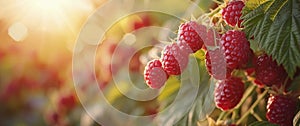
266;95;297;126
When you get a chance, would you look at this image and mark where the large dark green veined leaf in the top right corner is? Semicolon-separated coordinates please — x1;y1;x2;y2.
242;0;300;77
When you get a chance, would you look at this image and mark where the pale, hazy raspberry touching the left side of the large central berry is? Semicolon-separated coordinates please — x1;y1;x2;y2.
205;49;232;80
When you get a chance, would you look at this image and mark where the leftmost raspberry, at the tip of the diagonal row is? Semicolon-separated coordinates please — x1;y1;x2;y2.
144;59;168;89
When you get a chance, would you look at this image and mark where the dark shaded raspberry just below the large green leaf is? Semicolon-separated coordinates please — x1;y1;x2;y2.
255;54;287;86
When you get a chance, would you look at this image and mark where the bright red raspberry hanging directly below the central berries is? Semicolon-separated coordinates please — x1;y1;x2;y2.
215;77;244;111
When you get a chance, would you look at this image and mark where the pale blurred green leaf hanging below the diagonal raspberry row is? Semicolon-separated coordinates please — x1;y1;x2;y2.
156;57;215;126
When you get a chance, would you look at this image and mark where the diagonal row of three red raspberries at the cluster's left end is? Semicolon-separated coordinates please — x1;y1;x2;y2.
144;21;203;89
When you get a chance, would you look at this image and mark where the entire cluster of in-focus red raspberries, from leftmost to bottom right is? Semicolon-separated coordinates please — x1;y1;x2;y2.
144;0;297;126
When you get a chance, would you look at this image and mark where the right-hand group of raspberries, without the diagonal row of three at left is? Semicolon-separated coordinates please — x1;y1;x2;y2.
206;1;297;126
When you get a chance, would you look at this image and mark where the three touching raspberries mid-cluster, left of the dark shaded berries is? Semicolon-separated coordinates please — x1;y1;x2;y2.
206;30;252;111
